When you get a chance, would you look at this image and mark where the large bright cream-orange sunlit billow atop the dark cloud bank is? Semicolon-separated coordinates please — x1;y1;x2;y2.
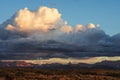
6;7;61;32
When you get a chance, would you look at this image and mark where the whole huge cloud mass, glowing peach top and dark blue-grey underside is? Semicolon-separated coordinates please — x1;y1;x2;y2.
0;6;120;57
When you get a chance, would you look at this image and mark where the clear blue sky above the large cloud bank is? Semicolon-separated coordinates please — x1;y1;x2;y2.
0;0;120;35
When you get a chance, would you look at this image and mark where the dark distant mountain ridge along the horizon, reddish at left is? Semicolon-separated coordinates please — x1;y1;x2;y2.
0;61;120;70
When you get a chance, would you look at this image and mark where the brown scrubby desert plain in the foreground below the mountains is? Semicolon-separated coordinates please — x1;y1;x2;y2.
0;68;120;80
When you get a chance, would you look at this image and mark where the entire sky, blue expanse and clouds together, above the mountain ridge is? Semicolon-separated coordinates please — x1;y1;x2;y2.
0;0;120;63
